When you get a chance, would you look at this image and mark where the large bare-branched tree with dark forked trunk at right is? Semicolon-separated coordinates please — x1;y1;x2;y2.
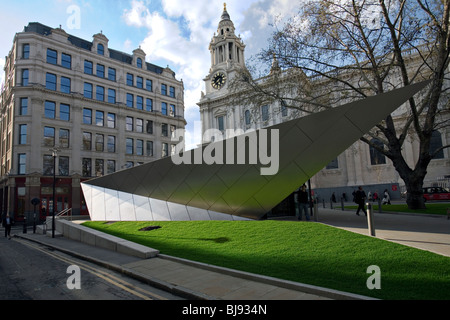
231;0;450;209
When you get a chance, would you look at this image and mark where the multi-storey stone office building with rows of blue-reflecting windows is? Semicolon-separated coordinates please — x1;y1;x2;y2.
0;23;186;220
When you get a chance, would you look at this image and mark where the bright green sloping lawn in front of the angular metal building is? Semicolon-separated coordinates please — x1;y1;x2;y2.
83;220;450;299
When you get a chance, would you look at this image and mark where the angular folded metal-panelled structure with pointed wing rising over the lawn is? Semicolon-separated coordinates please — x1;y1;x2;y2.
82;82;428;220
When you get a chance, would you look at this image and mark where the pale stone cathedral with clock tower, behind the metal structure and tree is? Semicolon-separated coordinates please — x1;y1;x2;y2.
198;7;450;212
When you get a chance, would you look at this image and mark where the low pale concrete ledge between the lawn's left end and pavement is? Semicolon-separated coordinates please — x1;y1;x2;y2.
55;219;159;259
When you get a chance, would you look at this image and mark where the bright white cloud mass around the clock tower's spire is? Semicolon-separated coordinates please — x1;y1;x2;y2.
123;0;274;146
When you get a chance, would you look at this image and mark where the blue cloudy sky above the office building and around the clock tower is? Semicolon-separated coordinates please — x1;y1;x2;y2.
0;0;302;149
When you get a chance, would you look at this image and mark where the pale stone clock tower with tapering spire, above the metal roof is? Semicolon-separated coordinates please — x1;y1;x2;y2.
198;4;245;142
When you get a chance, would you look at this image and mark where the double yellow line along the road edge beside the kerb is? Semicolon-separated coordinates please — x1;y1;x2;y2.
14;238;168;300
